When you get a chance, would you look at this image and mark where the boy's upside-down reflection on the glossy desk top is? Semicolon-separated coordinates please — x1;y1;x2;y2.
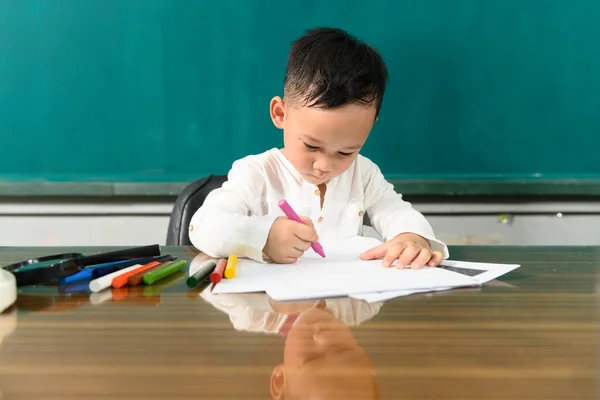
200;289;383;399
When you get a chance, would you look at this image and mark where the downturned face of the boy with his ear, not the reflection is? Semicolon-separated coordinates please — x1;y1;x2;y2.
271;97;375;185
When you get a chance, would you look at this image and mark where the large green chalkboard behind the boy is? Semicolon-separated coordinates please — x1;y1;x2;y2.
0;0;600;182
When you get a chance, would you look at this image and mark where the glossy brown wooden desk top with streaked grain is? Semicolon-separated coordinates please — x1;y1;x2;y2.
0;247;600;400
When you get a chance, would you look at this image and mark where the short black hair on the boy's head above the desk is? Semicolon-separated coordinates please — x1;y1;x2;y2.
284;28;388;115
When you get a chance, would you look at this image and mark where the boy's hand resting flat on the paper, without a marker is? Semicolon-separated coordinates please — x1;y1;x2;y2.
360;233;444;269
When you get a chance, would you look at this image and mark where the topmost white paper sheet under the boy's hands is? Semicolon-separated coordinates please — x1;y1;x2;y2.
213;237;479;301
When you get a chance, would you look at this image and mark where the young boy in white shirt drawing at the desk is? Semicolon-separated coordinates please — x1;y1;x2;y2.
189;28;448;268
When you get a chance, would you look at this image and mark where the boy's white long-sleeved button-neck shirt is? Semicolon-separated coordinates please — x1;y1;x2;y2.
189;148;448;262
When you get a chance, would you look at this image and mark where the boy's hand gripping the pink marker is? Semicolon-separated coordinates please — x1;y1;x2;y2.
263;217;319;264
